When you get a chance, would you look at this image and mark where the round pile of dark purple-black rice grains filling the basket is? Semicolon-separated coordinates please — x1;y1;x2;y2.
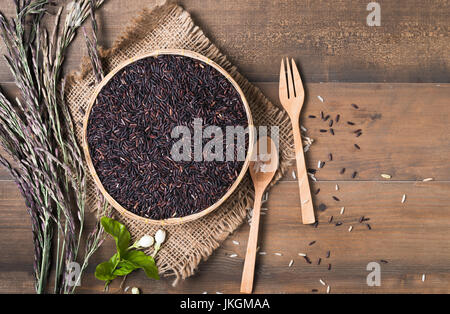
87;55;248;220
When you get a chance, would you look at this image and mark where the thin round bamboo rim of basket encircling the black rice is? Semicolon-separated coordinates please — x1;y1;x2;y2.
82;49;255;225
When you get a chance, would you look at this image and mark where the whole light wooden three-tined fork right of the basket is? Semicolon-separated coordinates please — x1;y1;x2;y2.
279;58;316;224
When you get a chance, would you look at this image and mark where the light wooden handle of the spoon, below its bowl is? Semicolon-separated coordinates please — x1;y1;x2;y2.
241;191;264;293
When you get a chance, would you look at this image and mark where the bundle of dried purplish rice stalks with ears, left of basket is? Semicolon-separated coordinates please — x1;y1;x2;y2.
0;0;108;293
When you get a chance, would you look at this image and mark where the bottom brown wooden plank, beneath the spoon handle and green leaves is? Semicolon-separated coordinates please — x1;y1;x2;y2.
0;181;450;293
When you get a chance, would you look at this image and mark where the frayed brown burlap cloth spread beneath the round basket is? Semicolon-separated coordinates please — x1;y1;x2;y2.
66;4;294;283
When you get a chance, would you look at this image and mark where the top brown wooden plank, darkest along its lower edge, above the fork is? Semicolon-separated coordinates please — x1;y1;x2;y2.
0;0;450;83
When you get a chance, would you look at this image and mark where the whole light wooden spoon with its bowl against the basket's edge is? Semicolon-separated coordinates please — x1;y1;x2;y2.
241;136;278;293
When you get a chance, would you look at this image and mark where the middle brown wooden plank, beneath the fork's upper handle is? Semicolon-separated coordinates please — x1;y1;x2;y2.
0;83;450;181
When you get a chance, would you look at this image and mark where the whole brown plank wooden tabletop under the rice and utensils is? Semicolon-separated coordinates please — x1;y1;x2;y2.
0;0;450;293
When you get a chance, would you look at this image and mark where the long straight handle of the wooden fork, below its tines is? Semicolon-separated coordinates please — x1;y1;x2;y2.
292;119;316;225
